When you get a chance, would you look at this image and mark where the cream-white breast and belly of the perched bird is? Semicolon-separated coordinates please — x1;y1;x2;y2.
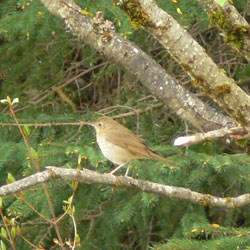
97;136;137;165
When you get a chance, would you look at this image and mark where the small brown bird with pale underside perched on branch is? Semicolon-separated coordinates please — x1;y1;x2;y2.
88;116;167;175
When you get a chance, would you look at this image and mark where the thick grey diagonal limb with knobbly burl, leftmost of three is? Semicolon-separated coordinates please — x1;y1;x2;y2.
40;0;233;131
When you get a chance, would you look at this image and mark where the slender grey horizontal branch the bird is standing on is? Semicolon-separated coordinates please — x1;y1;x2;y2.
0;166;250;208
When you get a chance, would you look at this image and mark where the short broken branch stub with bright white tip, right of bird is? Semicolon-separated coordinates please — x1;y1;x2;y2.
174;127;250;146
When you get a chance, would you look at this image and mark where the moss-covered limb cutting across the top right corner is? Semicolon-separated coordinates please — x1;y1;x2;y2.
199;0;250;62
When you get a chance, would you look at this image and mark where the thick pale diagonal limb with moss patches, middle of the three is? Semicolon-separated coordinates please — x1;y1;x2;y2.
115;0;250;126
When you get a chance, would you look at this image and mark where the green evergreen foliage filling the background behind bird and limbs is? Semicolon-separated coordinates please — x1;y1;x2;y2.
0;0;250;250
